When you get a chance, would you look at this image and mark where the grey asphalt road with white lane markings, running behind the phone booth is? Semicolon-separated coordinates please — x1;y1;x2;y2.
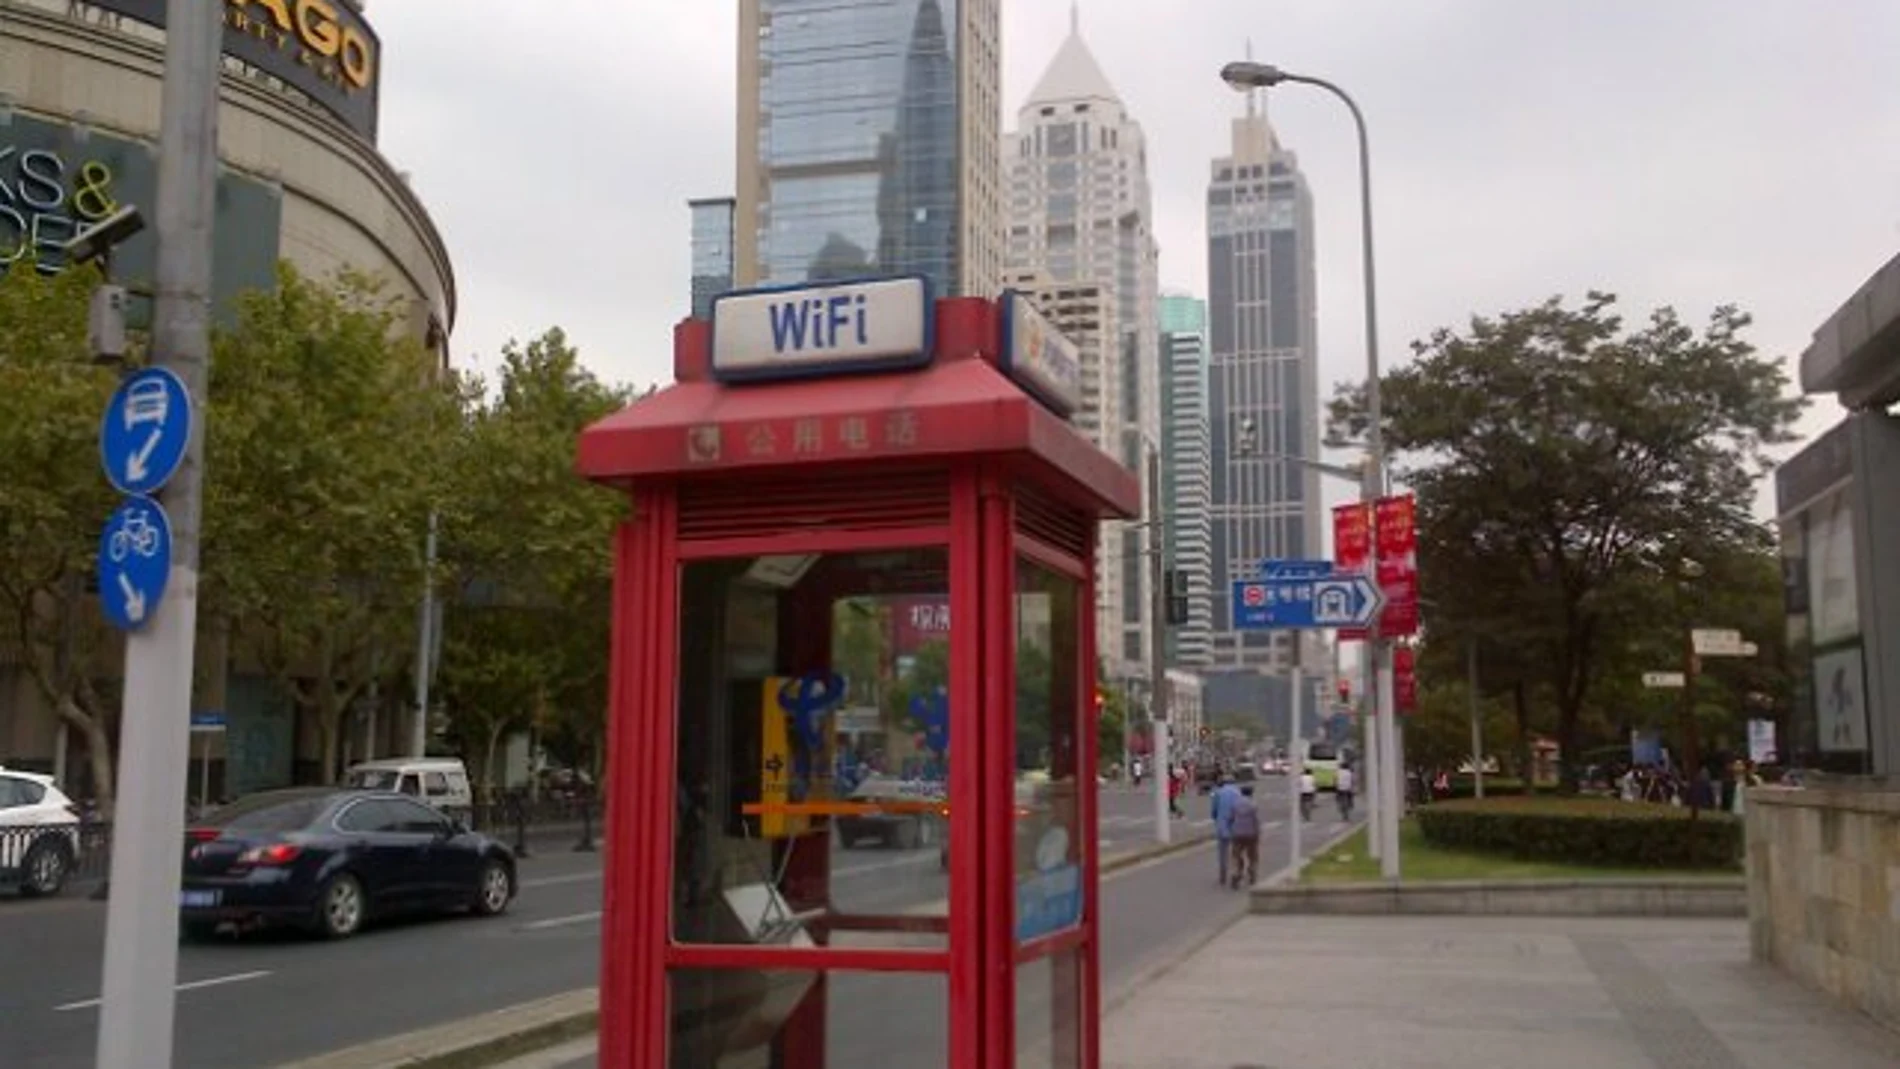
0;780;1360;1069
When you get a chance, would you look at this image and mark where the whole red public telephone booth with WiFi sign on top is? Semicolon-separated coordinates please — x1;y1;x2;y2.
580;279;1140;1069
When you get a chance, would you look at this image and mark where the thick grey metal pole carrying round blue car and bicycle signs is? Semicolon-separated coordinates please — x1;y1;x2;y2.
97;0;224;1069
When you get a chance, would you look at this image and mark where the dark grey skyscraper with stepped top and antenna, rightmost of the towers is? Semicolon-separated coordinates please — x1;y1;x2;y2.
1207;97;1322;670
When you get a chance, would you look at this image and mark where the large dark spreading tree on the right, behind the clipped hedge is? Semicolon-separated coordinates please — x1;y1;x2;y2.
1334;292;1803;784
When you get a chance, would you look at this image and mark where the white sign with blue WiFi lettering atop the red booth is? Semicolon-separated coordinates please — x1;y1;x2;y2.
713;277;931;382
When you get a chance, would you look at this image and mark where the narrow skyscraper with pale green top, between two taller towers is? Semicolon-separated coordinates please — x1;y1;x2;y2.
1161;294;1216;668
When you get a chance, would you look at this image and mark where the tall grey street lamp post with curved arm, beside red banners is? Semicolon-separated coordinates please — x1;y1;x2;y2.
1220;61;1404;881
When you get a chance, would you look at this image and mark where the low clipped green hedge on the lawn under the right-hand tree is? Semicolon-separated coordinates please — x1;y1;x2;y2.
1412;797;1742;870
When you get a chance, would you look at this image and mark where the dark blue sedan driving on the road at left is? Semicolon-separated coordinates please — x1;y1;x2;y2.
179;788;517;940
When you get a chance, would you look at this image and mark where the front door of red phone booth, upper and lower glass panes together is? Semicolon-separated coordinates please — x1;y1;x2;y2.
667;539;963;1069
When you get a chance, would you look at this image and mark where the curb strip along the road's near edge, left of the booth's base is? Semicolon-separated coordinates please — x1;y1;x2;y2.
277;987;600;1069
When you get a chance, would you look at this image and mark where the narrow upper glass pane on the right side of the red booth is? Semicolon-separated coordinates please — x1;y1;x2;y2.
1015;558;1094;944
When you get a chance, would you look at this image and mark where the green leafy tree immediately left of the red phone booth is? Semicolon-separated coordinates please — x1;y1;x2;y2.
441;328;629;782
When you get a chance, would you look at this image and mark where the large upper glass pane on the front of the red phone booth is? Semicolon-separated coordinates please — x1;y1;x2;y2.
673;549;952;949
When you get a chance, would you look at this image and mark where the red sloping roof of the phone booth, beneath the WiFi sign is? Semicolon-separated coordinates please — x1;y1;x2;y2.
576;298;1140;518
